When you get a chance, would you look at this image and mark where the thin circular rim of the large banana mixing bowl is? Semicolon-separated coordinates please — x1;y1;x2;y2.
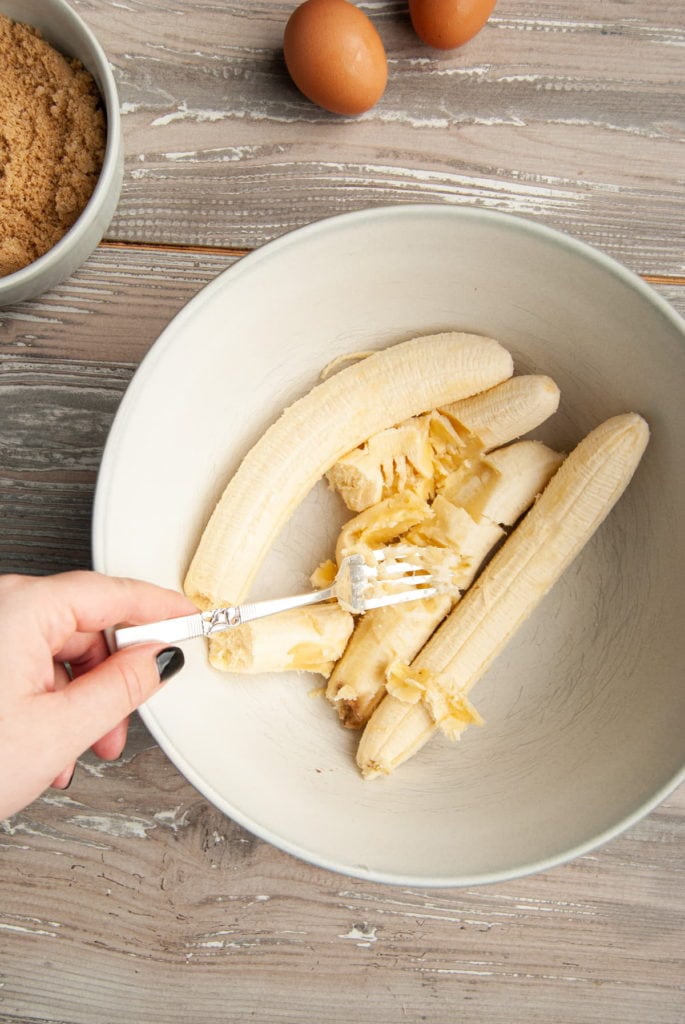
91;203;685;889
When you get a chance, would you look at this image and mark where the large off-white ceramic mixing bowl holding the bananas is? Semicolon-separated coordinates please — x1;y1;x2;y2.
93;206;685;886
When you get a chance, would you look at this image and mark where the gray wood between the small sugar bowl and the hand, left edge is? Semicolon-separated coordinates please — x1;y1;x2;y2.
0;247;236;574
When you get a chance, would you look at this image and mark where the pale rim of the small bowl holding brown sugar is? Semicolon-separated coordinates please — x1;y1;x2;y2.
0;0;123;299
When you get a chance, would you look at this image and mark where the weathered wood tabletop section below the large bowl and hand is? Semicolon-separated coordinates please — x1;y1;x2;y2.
0;720;685;1024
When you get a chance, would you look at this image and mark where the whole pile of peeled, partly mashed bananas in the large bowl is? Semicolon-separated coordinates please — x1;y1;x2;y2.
184;319;649;777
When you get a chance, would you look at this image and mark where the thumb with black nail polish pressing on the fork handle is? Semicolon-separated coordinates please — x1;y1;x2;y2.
50;644;185;759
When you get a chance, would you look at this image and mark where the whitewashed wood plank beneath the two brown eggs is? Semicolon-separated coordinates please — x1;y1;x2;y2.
65;0;685;273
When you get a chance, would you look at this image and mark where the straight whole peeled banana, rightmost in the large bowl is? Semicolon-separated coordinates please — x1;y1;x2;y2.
356;413;649;777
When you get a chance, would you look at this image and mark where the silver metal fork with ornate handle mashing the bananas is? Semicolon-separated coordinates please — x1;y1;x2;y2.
114;548;437;649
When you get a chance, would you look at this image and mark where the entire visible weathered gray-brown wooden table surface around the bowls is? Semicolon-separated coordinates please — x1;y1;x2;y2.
0;0;685;1024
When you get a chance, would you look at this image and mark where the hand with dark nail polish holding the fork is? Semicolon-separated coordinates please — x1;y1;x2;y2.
0;571;197;818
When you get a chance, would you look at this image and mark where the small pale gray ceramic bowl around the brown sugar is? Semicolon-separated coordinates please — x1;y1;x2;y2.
0;0;124;306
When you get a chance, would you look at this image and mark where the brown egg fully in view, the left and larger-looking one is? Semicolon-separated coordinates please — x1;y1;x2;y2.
283;0;388;115
